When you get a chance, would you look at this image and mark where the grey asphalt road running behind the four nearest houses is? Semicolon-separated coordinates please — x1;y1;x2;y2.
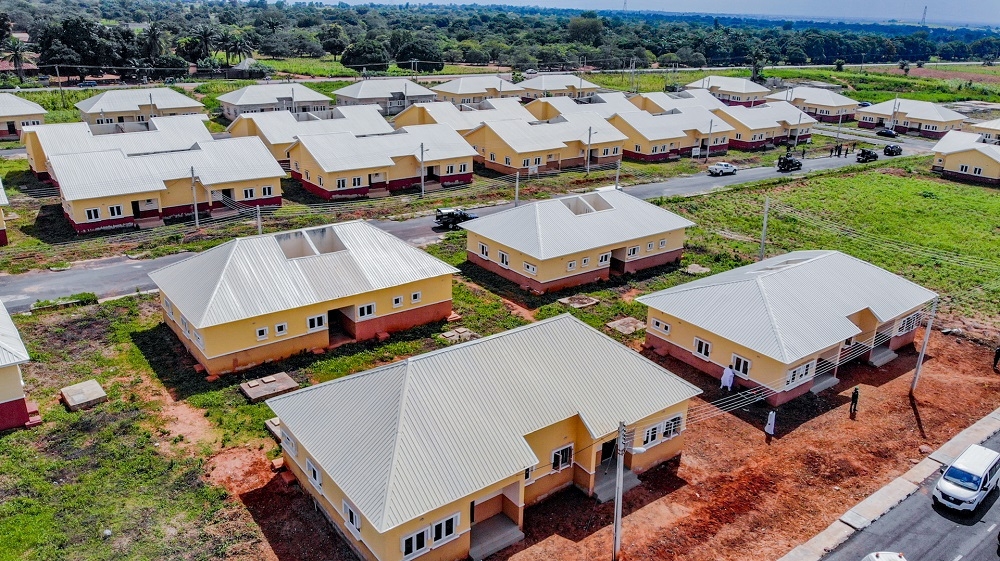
0;141;919;312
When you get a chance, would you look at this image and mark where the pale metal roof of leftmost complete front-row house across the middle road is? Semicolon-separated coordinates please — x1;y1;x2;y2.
49;136;285;201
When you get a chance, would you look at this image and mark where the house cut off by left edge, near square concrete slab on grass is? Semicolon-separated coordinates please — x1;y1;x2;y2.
0;305;42;431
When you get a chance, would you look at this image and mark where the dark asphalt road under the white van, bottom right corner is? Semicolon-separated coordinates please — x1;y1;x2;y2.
823;434;1000;561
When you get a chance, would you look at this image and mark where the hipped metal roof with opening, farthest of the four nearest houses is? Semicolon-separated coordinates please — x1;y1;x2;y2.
461;190;694;259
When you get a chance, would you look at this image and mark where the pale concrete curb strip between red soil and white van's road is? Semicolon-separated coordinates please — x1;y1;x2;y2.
778;402;1000;561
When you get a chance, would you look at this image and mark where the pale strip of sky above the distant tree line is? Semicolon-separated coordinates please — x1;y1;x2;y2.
366;0;1000;27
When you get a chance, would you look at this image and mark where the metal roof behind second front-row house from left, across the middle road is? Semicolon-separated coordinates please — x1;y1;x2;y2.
228;105;393;144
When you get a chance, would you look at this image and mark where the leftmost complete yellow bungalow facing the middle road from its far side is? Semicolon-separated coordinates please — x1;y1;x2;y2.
49;137;285;234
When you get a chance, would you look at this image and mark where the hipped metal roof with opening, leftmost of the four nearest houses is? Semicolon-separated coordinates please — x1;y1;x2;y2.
149;221;458;329
